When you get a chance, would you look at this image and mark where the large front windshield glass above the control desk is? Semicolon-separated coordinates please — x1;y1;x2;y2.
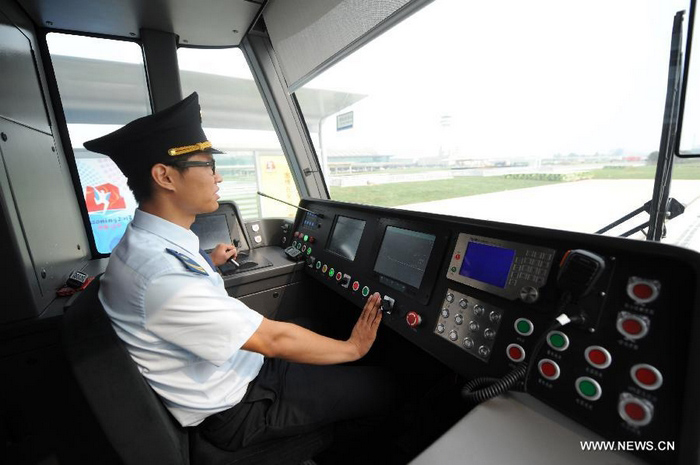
296;0;700;248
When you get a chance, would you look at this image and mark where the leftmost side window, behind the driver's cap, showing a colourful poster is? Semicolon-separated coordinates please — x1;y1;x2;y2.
46;33;151;254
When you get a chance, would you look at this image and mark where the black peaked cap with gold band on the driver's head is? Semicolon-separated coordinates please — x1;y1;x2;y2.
83;92;221;178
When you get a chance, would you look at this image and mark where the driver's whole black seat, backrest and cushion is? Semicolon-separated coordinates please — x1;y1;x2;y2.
63;278;332;465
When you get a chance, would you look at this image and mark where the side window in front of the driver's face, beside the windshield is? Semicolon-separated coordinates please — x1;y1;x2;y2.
178;48;299;219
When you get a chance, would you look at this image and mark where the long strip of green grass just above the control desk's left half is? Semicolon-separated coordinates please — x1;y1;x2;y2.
331;176;556;207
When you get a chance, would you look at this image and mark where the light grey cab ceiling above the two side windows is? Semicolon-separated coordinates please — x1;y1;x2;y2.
17;0;265;47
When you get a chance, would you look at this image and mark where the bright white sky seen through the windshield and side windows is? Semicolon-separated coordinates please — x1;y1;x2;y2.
49;0;700;158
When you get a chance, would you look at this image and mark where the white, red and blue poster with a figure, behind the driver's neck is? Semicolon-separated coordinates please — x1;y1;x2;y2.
76;157;136;253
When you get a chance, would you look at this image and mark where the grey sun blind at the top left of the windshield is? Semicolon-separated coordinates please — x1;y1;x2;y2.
263;0;428;92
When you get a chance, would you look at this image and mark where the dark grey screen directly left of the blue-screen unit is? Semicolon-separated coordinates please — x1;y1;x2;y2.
374;226;435;289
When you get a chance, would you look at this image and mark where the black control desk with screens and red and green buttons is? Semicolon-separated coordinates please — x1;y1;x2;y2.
291;199;700;463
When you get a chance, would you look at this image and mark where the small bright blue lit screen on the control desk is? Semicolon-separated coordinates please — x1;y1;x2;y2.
459;242;515;288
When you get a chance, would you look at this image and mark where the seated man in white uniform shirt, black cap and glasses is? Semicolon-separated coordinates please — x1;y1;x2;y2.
85;93;394;460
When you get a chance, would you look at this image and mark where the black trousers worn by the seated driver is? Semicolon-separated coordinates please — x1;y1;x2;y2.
200;359;397;458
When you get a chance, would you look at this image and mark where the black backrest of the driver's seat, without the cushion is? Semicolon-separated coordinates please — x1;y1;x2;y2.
63;278;189;465
